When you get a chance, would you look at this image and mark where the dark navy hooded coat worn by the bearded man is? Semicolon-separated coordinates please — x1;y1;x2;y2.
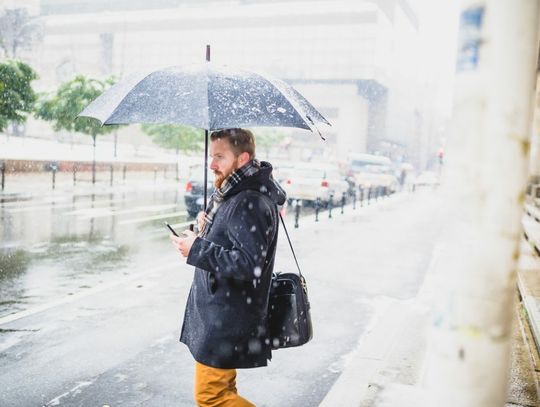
180;162;285;369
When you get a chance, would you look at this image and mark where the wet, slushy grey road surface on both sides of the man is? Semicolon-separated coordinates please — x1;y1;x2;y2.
0;175;440;406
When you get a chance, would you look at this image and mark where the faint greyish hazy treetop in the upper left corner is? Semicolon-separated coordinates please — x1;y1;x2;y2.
0;8;42;58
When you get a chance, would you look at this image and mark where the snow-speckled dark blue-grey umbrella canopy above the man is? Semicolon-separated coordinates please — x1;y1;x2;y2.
79;62;330;134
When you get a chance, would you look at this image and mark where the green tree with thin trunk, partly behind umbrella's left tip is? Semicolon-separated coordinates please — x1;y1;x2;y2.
35;75;118;184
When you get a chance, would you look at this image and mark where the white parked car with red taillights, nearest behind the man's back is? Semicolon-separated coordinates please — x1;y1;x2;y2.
282;163;349;205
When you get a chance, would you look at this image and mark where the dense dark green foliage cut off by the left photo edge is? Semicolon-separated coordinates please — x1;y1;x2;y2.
0;60;37;131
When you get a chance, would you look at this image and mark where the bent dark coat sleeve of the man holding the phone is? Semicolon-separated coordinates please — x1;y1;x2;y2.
187;193;277;281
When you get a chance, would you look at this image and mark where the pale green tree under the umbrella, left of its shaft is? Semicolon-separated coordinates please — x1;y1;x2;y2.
141;124;203;179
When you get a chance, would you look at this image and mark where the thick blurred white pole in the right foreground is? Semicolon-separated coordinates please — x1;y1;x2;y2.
424;0;539;407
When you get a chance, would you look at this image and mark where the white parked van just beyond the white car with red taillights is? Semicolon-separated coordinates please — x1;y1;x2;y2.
349;153;399;193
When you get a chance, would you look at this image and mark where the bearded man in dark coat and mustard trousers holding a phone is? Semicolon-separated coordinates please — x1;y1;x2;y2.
171;129;285;407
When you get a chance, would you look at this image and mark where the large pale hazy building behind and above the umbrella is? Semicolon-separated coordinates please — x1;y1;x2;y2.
19;0;420;166
